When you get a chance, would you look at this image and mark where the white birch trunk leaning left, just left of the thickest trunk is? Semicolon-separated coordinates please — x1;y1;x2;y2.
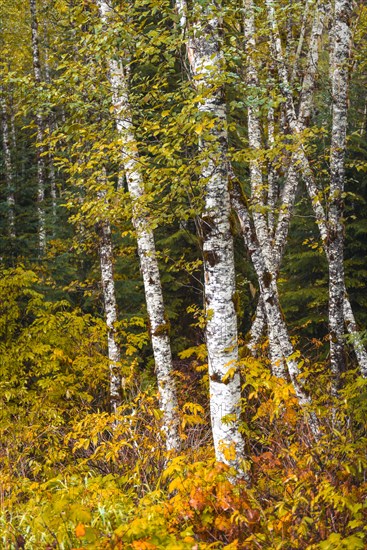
98;0;180;451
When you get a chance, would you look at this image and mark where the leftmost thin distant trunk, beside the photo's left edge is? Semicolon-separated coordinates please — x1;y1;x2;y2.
0;88;15;239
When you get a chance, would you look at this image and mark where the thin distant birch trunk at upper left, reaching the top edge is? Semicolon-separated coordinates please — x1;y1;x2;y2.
30;0;46;257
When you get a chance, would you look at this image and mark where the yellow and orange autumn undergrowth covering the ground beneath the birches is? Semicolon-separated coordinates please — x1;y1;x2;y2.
0;269;367;550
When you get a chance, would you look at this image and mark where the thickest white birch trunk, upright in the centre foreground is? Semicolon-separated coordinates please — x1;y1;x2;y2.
177;2;245;475
